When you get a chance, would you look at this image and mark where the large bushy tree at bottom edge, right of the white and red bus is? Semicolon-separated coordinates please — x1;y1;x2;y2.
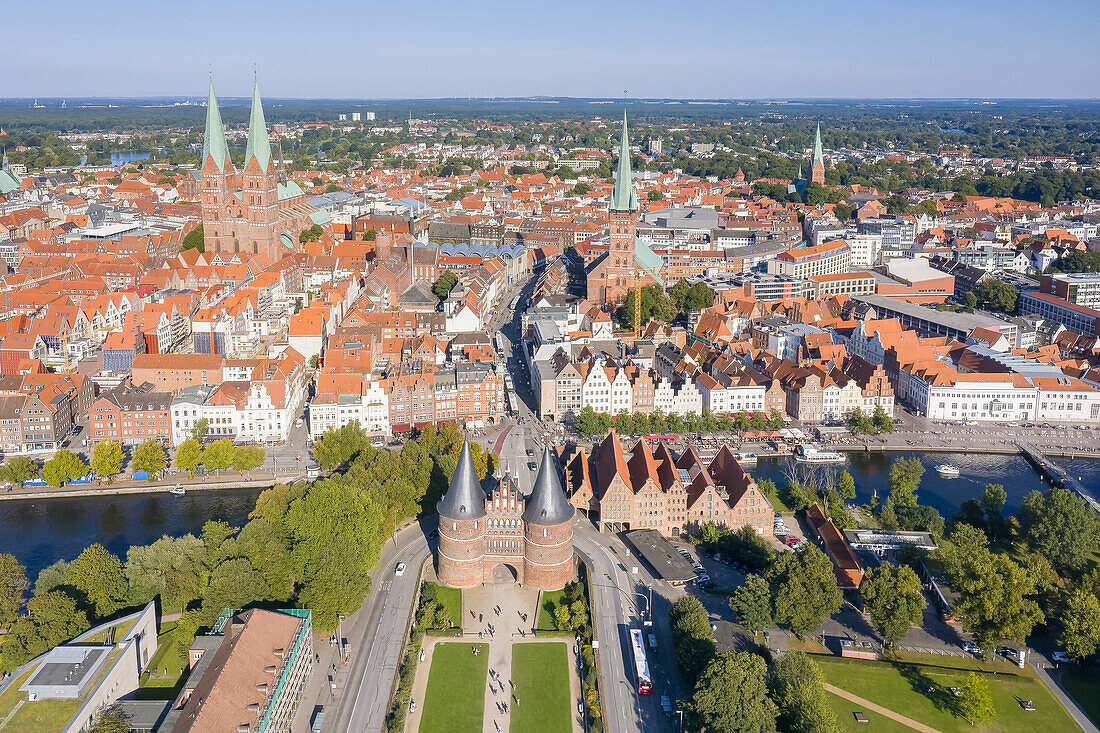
692;652;779;733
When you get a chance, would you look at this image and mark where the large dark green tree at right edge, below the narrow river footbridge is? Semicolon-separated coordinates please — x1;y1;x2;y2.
1020;489;1100;572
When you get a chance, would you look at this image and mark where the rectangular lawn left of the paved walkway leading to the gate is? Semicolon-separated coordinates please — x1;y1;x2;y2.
420;642;488;733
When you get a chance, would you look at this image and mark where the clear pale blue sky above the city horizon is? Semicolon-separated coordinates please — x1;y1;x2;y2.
8;0;1100;98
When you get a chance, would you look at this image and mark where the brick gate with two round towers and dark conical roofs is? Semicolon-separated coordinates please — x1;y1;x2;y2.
436;442;575;590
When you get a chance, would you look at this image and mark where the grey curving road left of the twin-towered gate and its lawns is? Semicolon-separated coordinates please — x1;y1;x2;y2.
314;522;433;732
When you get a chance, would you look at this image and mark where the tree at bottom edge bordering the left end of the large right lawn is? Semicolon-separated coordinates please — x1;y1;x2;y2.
768;652;840;733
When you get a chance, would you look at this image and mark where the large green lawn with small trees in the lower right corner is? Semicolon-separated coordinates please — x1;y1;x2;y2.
814;656;1080;733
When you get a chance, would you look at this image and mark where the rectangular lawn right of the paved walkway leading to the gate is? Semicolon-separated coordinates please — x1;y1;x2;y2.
510;642;573;733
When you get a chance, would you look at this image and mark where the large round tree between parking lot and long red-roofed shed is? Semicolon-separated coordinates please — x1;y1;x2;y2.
766;545;844;636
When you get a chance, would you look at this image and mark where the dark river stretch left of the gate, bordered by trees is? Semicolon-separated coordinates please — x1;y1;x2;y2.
0;489;261;583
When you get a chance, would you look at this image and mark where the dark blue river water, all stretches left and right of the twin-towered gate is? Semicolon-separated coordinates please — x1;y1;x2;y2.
0;452;1100;582
